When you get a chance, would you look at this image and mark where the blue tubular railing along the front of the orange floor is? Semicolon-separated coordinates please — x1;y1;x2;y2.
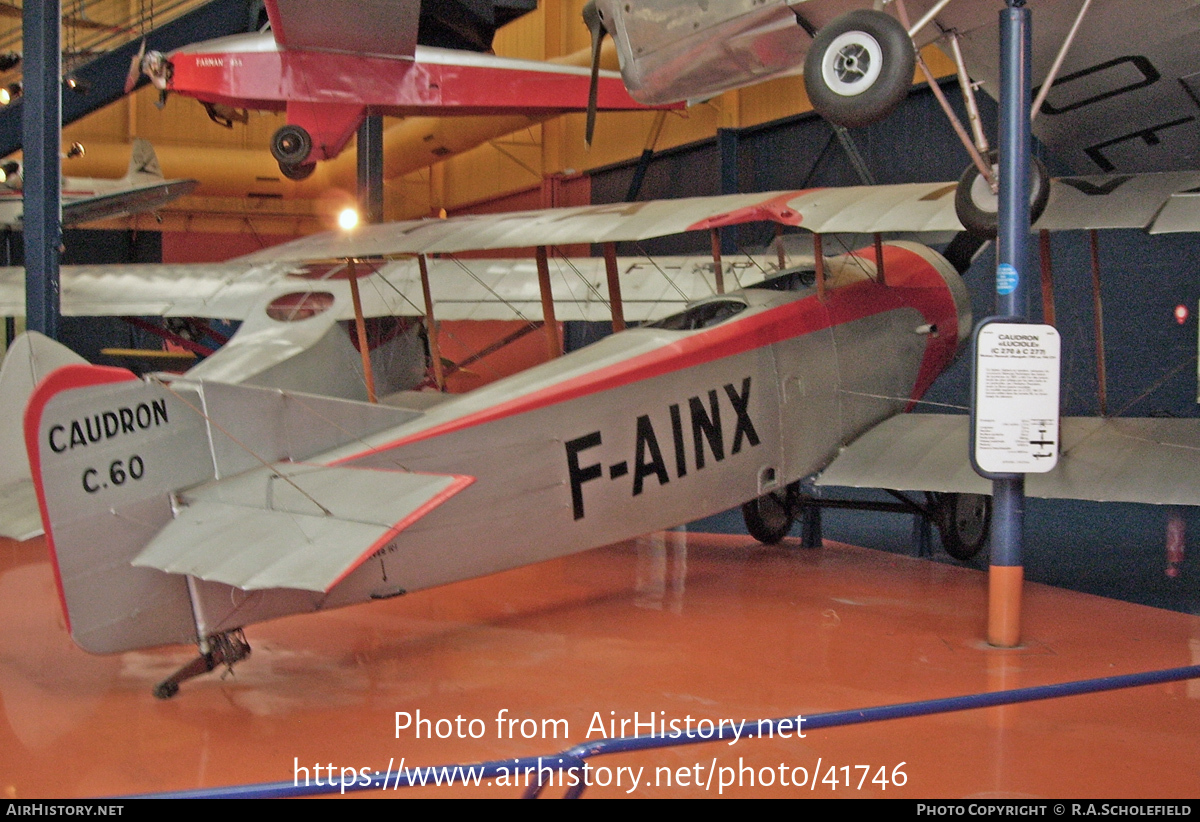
131;665;1200;799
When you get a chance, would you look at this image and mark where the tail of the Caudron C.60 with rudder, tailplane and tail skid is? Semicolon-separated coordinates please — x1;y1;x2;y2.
25;366;472;697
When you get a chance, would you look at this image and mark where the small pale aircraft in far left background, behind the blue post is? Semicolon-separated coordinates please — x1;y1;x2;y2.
0;138;198;228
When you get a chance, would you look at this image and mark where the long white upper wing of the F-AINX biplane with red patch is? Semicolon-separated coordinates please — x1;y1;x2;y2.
242;172;1200;263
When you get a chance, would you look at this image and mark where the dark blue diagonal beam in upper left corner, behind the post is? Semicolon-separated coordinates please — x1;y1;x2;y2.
0;0;258;160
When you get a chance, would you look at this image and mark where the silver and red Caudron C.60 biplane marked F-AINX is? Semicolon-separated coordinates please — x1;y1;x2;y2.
7;175;1200;697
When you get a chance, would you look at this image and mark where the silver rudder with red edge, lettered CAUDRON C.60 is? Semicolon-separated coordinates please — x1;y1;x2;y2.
25;365;214;653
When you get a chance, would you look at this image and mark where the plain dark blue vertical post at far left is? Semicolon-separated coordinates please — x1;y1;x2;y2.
22;0;62;340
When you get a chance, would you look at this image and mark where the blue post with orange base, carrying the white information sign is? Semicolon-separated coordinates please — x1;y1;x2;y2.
988;0;1032;648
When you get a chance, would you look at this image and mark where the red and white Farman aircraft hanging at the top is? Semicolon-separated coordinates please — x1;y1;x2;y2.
127;0;676;180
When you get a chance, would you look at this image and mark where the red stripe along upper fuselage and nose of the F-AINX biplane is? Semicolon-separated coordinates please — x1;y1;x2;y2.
332;246;958;464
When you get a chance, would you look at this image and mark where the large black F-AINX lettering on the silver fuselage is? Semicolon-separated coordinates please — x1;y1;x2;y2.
565;377;760;520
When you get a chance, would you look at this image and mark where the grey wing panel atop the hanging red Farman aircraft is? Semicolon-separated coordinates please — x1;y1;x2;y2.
265;0;421;58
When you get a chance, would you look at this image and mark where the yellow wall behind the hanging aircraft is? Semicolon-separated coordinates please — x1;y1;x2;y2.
28;0;952;233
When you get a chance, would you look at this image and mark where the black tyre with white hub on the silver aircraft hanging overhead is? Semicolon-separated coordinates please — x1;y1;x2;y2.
804;10;917;128
